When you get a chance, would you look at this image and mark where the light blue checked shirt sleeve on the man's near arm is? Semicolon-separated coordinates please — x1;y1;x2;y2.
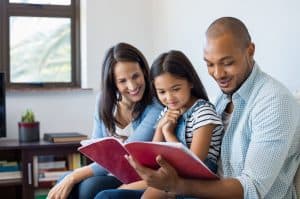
237;95;299;199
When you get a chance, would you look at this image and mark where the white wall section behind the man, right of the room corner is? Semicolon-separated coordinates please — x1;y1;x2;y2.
153;0;300;97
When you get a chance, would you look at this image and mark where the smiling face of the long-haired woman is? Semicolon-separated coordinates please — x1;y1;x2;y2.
114;62;146;104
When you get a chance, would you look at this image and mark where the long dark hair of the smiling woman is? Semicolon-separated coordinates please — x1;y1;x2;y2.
99;43;153;135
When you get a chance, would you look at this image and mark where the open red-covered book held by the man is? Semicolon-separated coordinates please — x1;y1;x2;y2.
78;137;218;184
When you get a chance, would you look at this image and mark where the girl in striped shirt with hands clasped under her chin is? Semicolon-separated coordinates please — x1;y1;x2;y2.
96;50;223;199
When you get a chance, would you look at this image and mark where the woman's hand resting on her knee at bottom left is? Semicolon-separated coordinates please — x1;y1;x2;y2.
47;174;75;199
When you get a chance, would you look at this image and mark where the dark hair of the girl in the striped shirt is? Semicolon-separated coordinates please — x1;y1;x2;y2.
150;50;208;101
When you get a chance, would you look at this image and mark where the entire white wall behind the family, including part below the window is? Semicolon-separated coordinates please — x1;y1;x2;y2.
6;0;300;138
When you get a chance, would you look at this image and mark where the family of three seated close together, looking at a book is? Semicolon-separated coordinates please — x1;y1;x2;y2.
48;17;300;199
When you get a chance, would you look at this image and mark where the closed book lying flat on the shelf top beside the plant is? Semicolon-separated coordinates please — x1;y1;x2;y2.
44;132;87;143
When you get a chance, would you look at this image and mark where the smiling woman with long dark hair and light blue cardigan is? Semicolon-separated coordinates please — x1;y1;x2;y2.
48;43;162;199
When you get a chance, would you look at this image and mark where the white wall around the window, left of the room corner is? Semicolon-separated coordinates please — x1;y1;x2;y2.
6;0;153;138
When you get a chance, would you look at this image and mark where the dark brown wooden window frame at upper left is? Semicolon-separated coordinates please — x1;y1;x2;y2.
0;0;81;89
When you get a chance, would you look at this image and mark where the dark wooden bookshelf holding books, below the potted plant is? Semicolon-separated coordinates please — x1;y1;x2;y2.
0;139;87;199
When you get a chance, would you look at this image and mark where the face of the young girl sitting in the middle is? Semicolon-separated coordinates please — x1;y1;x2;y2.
154;73;193;110
